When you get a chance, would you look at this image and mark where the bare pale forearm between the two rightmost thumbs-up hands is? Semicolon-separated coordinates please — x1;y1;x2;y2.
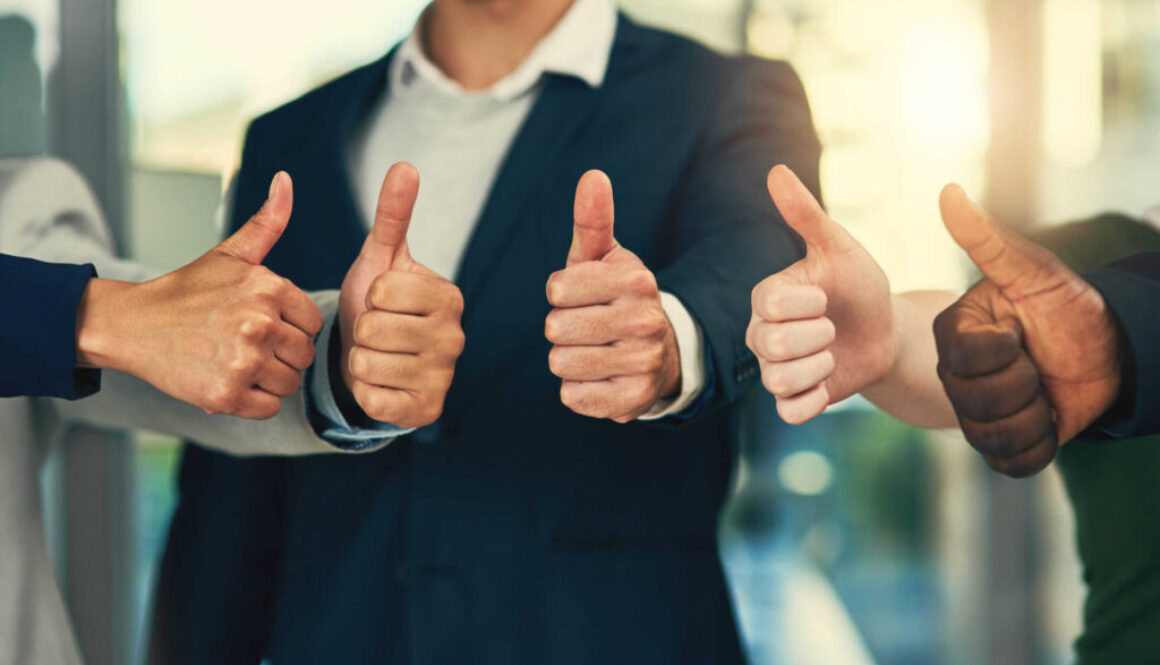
862;291;958;428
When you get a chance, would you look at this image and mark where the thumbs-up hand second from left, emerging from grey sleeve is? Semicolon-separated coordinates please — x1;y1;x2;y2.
339;164;464;427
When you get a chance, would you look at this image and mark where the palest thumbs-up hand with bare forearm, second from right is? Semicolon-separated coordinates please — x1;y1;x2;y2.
746;166;890;425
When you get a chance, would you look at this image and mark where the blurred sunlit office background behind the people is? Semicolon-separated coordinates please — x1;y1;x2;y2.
0;0;1160;665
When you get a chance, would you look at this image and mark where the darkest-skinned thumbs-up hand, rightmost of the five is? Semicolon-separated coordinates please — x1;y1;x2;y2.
935;186;1121;477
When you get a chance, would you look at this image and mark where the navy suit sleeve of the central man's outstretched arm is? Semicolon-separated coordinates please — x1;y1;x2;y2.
657;58;821;410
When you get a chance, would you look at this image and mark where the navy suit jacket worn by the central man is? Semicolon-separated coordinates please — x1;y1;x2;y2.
153;17;820;665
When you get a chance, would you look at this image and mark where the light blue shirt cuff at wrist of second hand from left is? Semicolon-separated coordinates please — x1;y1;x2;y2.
306;315;414;451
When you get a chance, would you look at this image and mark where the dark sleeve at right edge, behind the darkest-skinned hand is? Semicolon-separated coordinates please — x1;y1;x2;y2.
1085;252;1160;436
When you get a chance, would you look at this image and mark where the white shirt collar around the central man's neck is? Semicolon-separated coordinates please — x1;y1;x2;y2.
389;0;616;101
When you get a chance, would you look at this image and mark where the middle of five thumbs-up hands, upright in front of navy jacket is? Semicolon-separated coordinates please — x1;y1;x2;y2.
544;171;681;424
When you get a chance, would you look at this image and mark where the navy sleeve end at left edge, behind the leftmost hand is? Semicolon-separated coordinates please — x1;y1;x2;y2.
0;254;101;399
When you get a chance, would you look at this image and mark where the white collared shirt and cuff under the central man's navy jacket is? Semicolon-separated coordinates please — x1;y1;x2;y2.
316;0;705;436
